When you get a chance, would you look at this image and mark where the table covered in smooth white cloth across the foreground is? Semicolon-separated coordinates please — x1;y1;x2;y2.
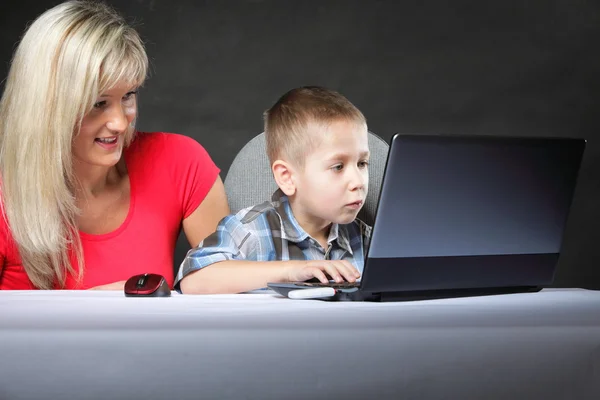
0;289;600;400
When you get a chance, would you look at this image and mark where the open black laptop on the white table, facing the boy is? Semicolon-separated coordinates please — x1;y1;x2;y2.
268;134;586;301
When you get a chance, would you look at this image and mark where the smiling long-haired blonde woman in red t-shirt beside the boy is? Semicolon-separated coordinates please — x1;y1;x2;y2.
0;1;229;290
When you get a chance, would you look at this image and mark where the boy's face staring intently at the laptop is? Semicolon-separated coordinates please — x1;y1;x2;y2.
293;121;369;226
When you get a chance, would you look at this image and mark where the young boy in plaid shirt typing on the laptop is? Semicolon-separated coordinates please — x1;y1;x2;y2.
175;87;371;293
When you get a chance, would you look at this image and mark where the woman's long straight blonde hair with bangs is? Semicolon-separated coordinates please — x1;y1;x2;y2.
0;1;148;289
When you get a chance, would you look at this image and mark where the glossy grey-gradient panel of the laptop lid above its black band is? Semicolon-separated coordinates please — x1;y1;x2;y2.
369;136;585;257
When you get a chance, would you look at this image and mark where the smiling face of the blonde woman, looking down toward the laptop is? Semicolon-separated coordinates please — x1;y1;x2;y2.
73;83;137;167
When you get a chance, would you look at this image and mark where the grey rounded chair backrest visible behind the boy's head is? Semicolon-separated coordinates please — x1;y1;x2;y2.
225;132;389;226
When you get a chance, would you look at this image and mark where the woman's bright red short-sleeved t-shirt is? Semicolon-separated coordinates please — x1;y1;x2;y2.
0;132;219;289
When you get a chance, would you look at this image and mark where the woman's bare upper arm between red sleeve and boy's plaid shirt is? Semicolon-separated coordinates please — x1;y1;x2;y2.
183;176;230;247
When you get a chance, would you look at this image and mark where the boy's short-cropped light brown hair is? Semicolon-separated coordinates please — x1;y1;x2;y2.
264;86;367;167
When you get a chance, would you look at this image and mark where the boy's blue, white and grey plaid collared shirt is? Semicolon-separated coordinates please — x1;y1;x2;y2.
175;190;371;286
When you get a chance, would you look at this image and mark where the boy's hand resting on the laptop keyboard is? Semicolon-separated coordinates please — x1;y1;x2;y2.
287;260;360;283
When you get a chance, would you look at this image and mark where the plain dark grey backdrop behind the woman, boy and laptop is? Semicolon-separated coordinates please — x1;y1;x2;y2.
0;0;600;289
